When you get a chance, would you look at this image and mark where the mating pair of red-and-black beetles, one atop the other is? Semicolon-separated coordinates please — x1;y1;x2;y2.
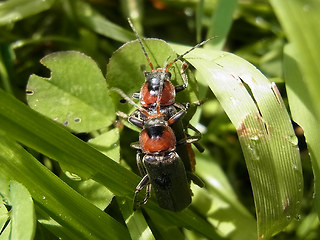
114;20;210;211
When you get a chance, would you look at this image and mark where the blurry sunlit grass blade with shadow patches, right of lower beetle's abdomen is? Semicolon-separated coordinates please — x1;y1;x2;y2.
193;151;257;239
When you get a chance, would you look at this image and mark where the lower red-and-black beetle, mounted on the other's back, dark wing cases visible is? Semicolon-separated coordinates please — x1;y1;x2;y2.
111;88;203;211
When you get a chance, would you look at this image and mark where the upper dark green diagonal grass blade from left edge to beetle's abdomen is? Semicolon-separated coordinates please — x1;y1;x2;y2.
0;90;138;195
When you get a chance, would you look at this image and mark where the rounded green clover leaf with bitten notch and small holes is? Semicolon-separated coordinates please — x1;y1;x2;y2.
27;51;115;132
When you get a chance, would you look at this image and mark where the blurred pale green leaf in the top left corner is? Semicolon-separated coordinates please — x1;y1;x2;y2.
0;0;54;25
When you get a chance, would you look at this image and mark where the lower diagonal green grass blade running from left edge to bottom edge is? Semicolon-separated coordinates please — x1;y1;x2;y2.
0;135;128;239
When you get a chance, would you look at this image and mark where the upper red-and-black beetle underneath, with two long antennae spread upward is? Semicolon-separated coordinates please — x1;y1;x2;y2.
128;19;210;172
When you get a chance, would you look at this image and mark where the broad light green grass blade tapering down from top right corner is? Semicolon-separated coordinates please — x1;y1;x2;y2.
270;0;320;120
